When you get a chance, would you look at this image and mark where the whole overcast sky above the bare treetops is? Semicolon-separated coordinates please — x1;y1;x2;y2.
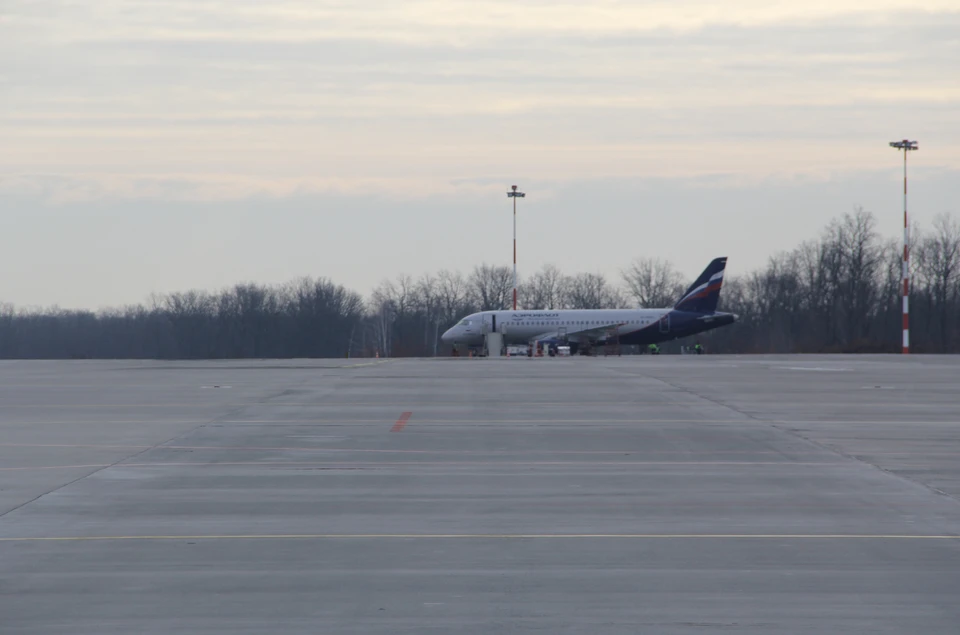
0;0;960;308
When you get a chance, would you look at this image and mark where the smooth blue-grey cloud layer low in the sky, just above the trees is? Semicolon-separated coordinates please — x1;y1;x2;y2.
0;168;960;307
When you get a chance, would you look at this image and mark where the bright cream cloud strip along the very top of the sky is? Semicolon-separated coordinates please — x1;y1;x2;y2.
7;0;957;43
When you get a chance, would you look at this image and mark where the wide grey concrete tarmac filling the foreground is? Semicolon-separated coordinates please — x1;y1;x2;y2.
0;356;960;635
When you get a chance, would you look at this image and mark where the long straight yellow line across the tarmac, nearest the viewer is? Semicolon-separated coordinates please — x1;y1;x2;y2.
0;534;960;542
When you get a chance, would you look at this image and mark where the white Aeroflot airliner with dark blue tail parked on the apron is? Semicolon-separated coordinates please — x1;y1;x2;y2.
441;258;737;354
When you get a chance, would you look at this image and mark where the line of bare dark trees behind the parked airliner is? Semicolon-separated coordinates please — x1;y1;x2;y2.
0;209;960;359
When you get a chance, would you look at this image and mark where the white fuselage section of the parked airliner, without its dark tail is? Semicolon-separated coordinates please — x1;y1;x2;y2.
443;309;670;344
